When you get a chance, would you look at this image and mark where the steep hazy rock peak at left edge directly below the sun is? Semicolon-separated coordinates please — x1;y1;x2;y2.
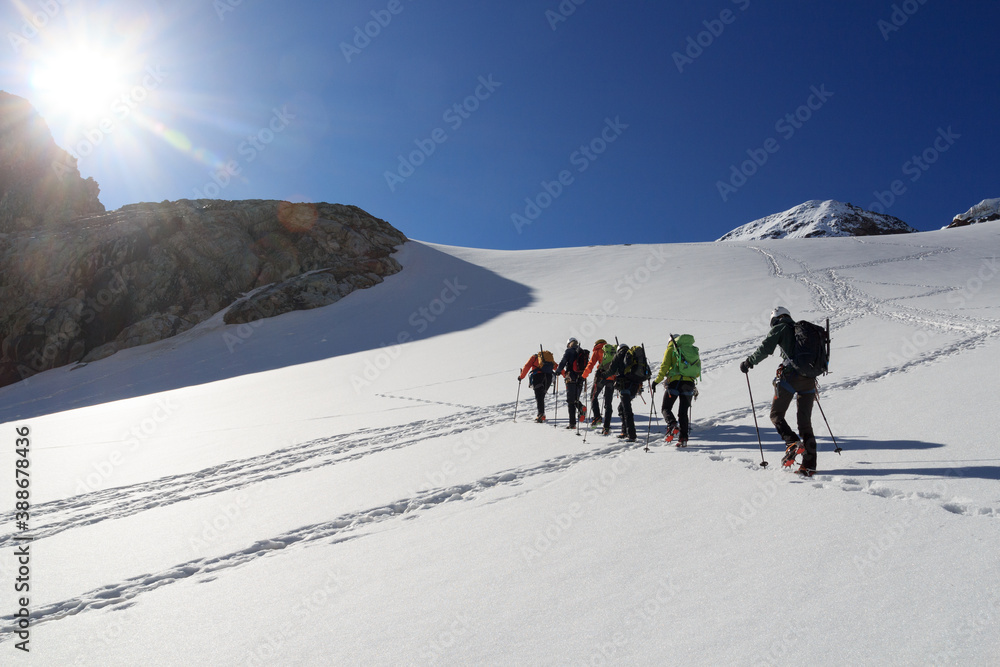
0;91;104;233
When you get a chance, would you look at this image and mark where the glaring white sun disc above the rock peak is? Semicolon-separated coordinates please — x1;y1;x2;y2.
31;46;128;122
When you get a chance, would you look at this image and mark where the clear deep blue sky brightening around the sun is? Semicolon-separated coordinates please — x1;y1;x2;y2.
0;0;1000;249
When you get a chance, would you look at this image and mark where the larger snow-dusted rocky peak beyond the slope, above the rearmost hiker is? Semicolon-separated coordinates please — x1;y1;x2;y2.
718;199;917;241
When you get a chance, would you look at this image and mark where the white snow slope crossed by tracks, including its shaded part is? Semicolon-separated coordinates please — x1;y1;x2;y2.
0;225;1000;665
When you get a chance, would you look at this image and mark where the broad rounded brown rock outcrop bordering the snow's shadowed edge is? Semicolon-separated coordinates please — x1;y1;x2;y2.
0;200;406;385
